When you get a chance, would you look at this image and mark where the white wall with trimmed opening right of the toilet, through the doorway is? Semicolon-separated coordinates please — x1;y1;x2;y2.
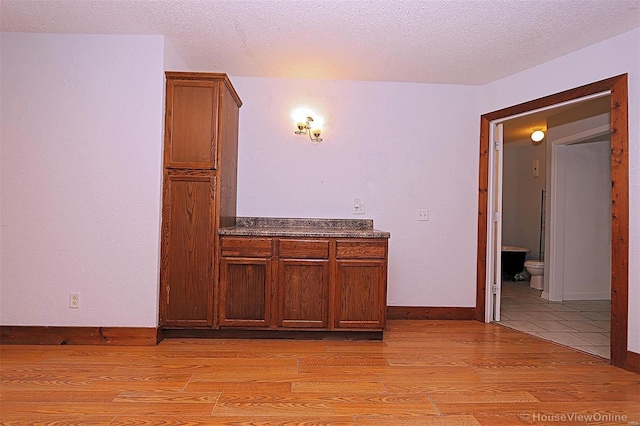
545;113;611;300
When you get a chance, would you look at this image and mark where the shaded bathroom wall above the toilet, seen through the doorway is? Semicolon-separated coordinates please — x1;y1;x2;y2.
502;140;546;259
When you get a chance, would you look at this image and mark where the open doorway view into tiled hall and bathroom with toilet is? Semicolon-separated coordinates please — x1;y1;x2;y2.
500;100;611;359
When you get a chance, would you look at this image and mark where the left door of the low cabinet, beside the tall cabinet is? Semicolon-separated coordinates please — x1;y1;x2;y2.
219;257;271;327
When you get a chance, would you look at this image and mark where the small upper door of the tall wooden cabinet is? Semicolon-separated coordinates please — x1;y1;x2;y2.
164;79;219;169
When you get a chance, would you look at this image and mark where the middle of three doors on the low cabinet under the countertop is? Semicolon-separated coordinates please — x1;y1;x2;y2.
278;259;329;328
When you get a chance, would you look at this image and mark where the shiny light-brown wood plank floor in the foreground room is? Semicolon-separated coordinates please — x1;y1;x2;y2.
0;320;640;426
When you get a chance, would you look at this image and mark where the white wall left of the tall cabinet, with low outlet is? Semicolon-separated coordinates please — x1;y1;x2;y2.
0;33;163;327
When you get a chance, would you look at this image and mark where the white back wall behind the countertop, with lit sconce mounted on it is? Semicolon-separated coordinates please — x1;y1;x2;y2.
231;77;479;307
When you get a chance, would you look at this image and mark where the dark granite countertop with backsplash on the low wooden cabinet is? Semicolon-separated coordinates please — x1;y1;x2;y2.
218;217;391;238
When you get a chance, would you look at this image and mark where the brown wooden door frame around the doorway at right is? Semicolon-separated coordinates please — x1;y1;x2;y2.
475;74;629;368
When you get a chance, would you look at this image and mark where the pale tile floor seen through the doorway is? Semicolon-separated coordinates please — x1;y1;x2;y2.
499;281;611;359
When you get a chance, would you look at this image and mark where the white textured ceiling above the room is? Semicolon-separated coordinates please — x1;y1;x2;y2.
0;0;640;84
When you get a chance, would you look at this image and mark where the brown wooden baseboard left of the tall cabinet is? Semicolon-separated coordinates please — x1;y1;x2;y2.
0;325;162;346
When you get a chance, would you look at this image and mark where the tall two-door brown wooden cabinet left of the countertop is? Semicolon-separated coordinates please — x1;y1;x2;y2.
160;72;242;328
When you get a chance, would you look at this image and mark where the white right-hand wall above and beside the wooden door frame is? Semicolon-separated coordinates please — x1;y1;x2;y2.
479;29;640;353
